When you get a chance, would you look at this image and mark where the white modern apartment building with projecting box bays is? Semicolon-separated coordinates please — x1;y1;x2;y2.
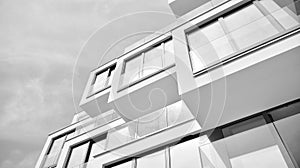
35;0;300;168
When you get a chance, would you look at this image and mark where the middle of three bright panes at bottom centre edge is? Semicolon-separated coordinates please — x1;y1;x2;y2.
137;150;166;168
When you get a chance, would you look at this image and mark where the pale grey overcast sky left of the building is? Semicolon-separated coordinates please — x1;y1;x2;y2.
0;0;175;168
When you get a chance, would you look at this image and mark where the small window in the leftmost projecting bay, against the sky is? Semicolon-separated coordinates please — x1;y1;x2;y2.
88;65;116;96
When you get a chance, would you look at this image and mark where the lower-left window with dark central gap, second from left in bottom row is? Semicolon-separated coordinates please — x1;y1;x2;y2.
66;135;106;168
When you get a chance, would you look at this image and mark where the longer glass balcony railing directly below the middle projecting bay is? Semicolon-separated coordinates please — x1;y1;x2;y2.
106;101;194;150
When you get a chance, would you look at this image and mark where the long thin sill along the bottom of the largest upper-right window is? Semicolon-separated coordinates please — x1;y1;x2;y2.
193;25;300;78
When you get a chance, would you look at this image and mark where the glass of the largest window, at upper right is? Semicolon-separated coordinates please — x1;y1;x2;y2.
187;0;299;73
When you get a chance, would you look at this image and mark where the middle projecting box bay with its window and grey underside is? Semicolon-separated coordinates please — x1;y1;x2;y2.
109;33;180;121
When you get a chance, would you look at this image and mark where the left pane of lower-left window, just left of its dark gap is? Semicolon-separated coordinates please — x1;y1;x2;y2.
67;143;89;168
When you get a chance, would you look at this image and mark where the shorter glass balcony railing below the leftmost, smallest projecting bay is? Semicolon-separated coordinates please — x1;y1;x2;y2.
70;110;120;138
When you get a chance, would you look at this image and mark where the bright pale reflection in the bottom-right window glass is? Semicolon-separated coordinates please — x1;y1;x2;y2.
230;145;288;168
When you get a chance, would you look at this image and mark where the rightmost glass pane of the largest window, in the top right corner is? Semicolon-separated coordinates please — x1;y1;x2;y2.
259;0;299;29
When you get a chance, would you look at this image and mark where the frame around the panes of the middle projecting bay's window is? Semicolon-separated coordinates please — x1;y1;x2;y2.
117;35;175;92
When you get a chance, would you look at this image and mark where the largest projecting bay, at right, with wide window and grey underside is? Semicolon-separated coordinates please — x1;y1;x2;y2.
175;0;300;130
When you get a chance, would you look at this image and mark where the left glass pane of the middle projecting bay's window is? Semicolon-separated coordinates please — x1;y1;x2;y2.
122;55;142;85
